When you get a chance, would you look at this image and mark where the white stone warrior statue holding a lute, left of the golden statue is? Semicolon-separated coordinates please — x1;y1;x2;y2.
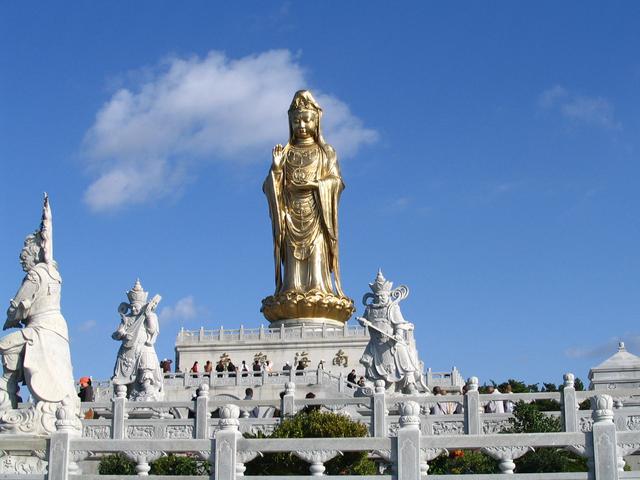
111;280;164;401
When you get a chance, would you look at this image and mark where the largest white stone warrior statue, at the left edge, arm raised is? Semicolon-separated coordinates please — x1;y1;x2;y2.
0;193;80;434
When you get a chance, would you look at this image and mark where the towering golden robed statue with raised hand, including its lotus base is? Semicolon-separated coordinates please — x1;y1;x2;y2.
261;90;354;326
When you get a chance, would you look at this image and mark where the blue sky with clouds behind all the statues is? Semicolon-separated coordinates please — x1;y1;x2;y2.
0;2;640;383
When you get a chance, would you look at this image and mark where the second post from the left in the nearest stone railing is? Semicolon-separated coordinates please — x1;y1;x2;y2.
214;404;240;480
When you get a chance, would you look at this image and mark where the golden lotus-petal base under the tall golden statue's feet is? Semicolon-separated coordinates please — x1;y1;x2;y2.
260;292;356;327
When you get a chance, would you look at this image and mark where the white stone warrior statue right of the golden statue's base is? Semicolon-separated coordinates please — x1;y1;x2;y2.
358;271;427;393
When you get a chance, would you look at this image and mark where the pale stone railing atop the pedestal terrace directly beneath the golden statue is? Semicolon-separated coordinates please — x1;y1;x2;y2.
176;324;369;346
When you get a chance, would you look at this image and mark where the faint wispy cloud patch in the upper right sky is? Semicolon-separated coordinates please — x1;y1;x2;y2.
538;85;620;129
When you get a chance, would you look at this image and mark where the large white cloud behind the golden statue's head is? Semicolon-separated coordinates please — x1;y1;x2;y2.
85;50;377;211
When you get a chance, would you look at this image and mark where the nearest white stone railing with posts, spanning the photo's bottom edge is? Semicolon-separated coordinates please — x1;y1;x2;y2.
0;392;640;480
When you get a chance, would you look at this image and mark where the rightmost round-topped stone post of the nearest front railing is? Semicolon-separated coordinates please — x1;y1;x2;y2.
591;395;618;480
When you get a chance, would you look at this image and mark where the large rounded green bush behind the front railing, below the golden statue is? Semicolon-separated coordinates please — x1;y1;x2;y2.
245;411;376;475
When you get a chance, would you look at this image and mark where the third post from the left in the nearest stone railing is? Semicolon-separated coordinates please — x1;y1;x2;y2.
395;402;420;480
